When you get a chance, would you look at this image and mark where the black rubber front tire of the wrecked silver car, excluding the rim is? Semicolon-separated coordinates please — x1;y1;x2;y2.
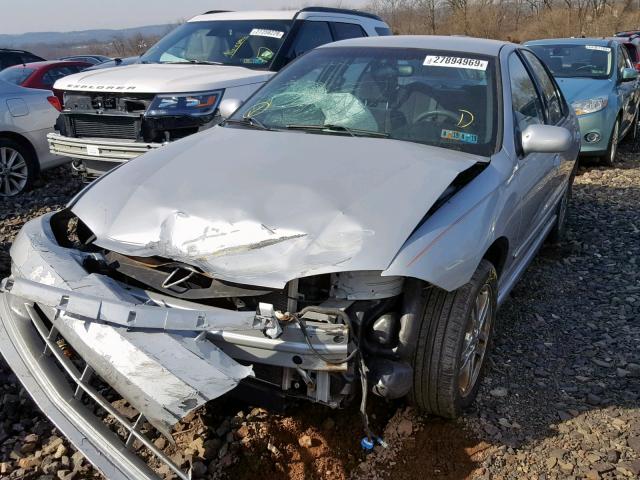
409;260;498;418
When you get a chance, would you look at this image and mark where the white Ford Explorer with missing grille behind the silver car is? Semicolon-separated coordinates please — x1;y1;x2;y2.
48;7;390;179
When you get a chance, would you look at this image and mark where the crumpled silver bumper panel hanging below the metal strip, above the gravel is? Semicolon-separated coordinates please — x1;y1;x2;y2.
54;315;253;437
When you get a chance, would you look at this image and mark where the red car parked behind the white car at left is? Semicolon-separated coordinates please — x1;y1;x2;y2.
0;60;92;103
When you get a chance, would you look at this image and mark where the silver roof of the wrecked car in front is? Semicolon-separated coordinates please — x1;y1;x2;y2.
319;35;515;56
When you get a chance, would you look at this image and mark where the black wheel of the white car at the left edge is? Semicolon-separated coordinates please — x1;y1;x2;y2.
0;138;38;198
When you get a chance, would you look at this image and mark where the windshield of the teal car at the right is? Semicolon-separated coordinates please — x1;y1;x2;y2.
529;44;613;78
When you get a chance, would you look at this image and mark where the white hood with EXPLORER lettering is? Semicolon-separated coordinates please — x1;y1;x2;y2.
54;64;273;93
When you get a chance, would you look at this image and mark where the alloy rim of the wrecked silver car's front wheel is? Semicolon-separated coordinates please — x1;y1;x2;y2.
458;284;493;397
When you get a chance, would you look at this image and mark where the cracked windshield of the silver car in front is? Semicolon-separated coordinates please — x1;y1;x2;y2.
229;47;498;156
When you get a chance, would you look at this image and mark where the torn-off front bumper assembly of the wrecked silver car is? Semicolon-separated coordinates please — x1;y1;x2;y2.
0;214;348;479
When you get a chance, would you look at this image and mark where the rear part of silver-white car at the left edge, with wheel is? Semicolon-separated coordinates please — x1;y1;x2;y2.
0;80;67;197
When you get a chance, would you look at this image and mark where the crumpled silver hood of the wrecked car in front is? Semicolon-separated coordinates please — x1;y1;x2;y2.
72;127;486;288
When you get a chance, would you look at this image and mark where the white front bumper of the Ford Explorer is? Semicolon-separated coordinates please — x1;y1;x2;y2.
47;133;164;177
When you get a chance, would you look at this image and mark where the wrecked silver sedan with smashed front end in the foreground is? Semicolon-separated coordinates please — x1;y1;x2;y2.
0;37;580;479
